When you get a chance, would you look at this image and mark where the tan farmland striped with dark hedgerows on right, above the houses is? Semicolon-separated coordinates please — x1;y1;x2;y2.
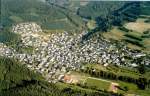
102;18;150;52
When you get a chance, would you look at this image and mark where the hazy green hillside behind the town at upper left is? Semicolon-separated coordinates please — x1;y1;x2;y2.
1;0;82;30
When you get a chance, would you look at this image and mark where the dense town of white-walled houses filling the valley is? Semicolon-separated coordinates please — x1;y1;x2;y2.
0;22;150;82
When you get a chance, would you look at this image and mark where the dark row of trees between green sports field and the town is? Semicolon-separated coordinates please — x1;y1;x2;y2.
81;67;150;90
